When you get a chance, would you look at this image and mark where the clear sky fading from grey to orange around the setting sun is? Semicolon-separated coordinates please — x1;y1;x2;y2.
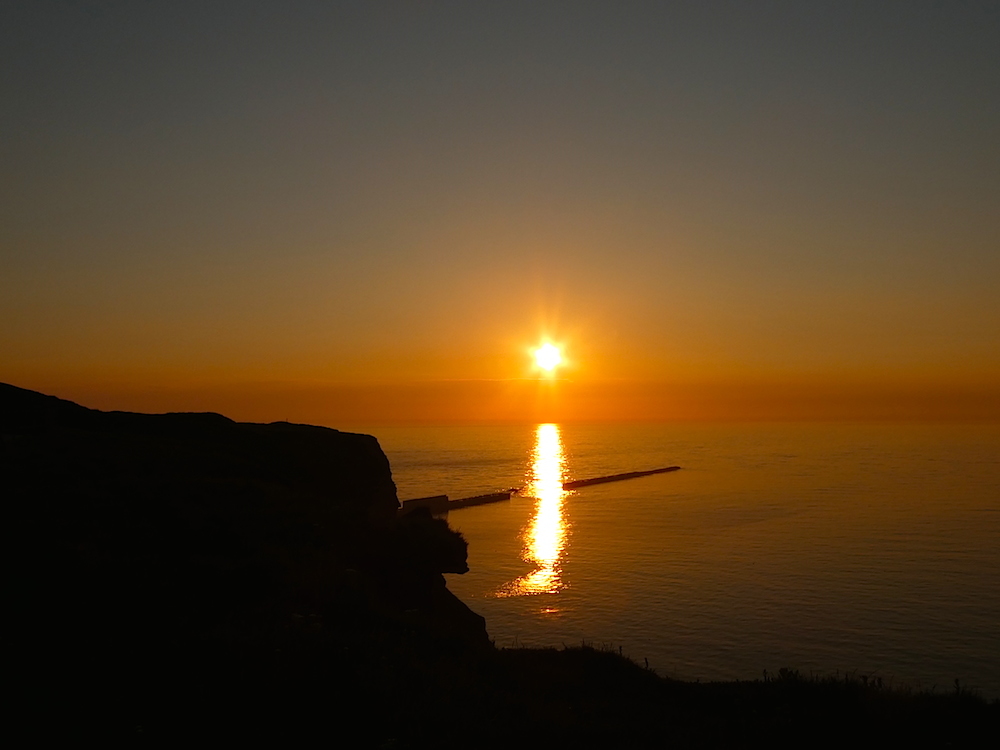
0;0;1000;426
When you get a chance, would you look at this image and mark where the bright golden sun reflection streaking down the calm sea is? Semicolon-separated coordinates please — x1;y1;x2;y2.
497;424;568;597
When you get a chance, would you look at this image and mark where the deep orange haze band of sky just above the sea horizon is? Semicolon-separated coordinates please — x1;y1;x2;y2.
9;379;1000;429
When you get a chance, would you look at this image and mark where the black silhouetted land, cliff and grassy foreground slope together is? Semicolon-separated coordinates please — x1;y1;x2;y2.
0;384;1000;748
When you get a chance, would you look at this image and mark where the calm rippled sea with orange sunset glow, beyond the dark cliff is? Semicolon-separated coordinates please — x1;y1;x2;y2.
348;424;1000;697
